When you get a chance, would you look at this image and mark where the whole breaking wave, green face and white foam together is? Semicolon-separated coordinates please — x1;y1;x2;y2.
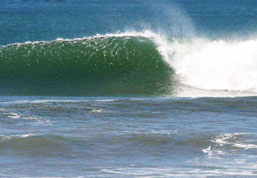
0;31;257;96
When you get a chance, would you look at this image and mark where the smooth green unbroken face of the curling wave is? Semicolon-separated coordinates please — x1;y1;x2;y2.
0;35;173;96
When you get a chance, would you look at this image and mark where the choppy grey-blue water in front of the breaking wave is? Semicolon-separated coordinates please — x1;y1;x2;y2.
0;97;257;177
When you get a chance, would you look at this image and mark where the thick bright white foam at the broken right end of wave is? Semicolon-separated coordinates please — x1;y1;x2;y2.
168;39;257;95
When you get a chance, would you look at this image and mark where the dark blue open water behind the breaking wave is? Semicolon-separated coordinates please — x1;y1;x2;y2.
3;0;257;45
